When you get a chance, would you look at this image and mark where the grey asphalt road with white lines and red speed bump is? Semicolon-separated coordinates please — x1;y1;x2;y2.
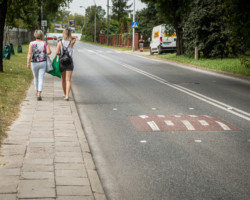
72;42;250;200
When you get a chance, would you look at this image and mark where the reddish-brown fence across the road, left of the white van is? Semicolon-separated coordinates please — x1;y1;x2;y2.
99;33;139;50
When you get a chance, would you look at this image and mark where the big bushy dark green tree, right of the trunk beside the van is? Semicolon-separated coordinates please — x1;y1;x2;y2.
184;0;229;58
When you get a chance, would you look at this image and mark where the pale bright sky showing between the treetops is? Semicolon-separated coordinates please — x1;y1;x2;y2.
67;0;146;15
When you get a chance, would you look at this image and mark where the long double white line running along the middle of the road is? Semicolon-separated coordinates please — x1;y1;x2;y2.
83;50;250;121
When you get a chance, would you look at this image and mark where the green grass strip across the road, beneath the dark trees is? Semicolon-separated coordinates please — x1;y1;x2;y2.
155;53;250;76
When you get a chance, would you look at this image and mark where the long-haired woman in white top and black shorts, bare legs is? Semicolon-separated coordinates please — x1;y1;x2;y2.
56;28;75;101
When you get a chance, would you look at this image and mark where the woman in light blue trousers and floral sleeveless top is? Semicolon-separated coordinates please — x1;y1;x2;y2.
27;30;51;101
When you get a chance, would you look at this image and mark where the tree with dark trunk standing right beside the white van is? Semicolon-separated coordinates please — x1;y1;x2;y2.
141;0;192;55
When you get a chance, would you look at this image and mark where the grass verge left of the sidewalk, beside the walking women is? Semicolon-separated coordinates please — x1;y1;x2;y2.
0;45;33;143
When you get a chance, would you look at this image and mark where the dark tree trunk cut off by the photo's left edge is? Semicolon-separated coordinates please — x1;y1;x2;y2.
0;0;8;72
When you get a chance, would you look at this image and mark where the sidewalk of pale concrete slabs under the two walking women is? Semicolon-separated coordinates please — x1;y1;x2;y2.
0;44;106;200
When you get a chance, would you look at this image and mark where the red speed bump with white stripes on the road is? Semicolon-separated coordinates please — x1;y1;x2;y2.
129;115;239;132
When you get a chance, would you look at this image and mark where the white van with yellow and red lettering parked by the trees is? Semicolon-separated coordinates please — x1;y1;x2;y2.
150;24;176;55
